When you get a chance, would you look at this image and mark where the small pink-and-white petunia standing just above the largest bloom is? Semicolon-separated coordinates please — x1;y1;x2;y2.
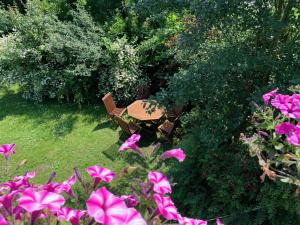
86;166;116;187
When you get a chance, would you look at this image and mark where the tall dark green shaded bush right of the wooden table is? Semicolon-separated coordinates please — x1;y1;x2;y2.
155;0;300;225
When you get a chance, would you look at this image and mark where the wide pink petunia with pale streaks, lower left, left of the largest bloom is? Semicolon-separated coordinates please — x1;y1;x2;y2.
17;188;65;212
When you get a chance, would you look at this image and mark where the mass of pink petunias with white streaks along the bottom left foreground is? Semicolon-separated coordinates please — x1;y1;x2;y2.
0;134;222;225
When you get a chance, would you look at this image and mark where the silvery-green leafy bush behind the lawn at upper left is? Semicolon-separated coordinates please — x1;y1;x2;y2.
0;2;144;103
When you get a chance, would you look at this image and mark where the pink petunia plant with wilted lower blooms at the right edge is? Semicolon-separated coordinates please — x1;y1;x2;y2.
241;88;300;186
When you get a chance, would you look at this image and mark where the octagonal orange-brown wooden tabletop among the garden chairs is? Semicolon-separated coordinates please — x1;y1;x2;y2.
127;100;165;120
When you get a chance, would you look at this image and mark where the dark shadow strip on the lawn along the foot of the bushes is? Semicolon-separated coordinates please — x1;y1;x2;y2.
0;86;106;135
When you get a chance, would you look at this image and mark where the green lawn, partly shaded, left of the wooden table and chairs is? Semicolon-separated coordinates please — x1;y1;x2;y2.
0;87;159;184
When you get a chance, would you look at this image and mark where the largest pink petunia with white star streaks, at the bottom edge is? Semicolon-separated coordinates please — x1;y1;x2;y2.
86;187;128;225
